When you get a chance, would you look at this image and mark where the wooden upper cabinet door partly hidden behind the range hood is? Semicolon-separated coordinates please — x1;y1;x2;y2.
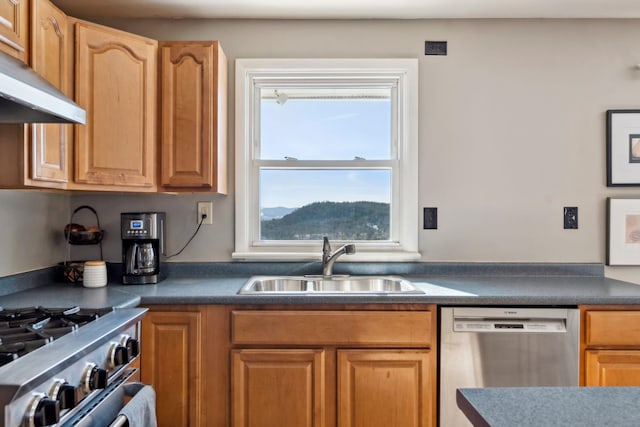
29;0;73;183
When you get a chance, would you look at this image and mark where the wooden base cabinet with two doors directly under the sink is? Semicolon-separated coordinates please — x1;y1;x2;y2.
231;306;436;427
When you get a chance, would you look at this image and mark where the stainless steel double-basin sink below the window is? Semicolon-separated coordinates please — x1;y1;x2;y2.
238;276;424;295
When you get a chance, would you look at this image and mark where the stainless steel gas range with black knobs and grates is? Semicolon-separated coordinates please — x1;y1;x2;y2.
0;307;152;427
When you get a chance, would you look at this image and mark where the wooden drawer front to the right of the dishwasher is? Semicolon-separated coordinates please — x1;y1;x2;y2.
585;311;640;346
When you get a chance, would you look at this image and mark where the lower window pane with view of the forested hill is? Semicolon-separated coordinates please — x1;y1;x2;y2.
259;169;391;240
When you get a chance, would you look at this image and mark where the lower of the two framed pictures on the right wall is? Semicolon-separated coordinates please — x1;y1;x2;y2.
607;198;640;265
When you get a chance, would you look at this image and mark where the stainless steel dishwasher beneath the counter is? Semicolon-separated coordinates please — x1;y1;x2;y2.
439;307;580;427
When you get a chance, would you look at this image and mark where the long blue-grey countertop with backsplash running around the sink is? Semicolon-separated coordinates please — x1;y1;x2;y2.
0;263;640;308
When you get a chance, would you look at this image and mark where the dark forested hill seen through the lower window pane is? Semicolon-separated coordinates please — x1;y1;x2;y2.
260;202;390;240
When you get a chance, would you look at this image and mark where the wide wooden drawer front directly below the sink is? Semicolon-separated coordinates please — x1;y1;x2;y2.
231;310;433;347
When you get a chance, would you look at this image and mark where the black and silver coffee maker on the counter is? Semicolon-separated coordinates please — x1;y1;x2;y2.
120;212;166;285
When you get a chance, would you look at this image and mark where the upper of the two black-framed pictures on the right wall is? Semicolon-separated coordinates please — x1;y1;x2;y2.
607;110;640;187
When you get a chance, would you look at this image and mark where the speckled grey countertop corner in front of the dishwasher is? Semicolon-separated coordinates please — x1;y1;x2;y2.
456;387;640;427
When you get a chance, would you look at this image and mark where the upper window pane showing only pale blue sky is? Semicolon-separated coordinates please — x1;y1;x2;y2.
260;88;391;160
